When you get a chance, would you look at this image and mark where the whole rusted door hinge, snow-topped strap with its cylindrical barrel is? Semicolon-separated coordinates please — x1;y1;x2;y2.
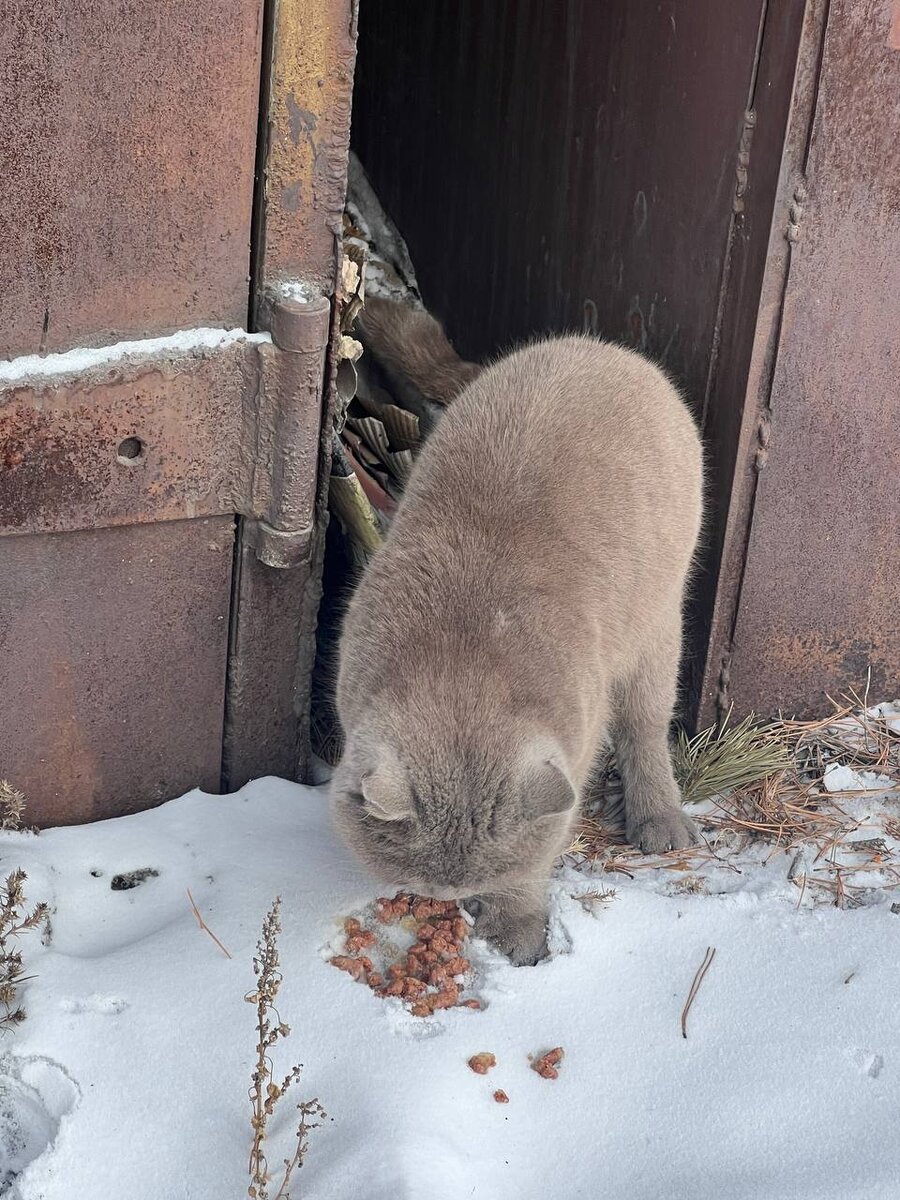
0;283;331;568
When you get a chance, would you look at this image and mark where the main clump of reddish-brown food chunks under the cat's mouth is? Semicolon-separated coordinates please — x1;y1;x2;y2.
330;892;481;1012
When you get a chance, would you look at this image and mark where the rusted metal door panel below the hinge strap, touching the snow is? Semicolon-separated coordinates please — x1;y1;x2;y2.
0;517;234;826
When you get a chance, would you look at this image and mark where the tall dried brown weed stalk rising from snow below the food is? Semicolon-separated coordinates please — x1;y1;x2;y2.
244;896;326;1200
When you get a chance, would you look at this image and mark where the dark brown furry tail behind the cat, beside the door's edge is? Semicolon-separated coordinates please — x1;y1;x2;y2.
359;296;481;404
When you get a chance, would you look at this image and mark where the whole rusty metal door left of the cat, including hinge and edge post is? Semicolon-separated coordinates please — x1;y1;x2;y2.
0;0;355;823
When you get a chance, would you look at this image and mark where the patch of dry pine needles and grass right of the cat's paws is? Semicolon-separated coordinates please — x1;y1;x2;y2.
569;692;900;907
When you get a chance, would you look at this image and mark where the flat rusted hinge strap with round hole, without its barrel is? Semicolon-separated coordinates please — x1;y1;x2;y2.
0;335;266;534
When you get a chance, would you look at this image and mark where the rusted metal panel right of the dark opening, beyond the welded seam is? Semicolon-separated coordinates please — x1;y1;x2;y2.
725;0;900;715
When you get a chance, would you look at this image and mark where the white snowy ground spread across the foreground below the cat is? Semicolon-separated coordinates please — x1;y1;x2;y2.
0;753;900;1200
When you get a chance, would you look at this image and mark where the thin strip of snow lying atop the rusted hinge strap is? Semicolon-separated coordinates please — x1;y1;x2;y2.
0;329;271;385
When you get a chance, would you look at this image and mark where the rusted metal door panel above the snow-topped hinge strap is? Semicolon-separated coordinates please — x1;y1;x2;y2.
0;0;262;355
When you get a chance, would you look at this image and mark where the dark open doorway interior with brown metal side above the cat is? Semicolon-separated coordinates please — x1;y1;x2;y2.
353;0;815;709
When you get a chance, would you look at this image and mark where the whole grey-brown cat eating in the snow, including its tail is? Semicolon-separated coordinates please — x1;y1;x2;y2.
331;300;702;964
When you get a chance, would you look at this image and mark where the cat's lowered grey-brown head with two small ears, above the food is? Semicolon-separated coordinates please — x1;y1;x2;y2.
331;730;576;899
